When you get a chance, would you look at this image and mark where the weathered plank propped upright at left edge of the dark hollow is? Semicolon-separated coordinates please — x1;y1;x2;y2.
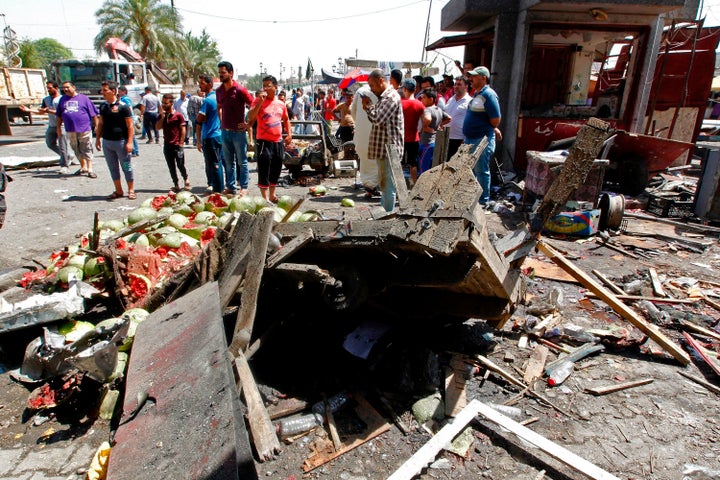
230;210;274;356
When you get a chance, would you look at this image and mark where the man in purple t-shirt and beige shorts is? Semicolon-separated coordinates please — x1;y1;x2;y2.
55;82;98;178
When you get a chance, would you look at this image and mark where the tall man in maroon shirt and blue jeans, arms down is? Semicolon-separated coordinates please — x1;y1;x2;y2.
215;61;253;195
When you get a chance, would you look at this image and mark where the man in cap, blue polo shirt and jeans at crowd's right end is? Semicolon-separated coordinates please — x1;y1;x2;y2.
463;67;500;205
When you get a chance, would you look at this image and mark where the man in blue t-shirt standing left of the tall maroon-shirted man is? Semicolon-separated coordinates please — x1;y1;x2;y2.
195;75;224;193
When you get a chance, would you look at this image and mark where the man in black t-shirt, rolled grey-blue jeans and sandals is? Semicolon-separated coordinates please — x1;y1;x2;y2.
95;81;137;200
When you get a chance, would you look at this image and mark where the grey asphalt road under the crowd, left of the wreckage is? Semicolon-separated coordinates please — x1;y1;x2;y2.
0;124;372;271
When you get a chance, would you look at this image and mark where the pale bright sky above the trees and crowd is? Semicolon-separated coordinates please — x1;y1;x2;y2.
0;0;720;79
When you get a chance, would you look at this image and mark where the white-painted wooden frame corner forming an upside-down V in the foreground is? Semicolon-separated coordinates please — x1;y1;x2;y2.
388;400;619;480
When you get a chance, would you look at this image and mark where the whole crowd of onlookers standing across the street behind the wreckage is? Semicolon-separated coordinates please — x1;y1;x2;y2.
25;61;501;211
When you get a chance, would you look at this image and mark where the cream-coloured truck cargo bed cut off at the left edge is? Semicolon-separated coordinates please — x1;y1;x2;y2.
0;68;47;135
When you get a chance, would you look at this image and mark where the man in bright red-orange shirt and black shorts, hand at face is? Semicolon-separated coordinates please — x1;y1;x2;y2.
248;75;292;203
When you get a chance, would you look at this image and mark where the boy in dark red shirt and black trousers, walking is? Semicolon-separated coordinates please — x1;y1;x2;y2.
156;93;190;192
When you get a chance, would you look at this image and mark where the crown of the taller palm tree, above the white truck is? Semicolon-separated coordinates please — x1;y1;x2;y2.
94;0;183;62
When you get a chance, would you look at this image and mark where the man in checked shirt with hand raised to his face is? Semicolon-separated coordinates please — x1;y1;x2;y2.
361;68;404;212
